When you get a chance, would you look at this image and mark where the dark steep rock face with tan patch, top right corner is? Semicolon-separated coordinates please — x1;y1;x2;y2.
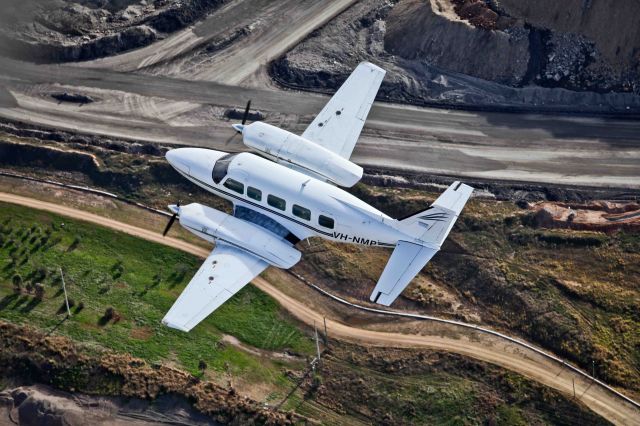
385;0;640;92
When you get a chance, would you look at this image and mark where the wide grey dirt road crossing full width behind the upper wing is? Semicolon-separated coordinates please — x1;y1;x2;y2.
0;58;640;188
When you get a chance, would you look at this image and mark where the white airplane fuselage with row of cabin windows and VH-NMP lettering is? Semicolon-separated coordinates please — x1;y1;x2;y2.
167;148;404;247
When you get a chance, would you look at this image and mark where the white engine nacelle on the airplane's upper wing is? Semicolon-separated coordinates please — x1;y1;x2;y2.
242;121;363;187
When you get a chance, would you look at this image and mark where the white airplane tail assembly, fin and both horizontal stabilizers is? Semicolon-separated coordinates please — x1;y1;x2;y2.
371;182;473;306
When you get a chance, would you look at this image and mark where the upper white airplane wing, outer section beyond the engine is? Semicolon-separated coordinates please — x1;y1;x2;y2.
302;62;386;159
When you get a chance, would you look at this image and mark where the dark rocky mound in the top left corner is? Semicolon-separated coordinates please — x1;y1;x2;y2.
0;0;223;62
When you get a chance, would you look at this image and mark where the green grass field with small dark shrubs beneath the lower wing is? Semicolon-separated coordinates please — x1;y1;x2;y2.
0;203;313;384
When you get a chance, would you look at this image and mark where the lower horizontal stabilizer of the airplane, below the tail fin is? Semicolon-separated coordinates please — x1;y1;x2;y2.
371;241;438;306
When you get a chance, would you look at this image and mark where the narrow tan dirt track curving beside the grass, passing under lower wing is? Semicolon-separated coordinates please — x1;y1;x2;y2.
0;192;640;425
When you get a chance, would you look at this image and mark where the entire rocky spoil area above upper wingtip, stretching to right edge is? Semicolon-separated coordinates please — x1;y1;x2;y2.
271;0;640;113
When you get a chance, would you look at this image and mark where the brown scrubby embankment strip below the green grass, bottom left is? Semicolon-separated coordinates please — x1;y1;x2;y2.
0;322;299;424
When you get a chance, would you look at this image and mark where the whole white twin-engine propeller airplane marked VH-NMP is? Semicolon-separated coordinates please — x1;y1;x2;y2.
162;63;473;331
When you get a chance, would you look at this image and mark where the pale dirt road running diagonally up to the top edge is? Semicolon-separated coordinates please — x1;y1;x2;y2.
76;0;355;84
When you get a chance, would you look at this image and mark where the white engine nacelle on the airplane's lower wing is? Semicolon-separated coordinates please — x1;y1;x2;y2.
176;203;301;269
